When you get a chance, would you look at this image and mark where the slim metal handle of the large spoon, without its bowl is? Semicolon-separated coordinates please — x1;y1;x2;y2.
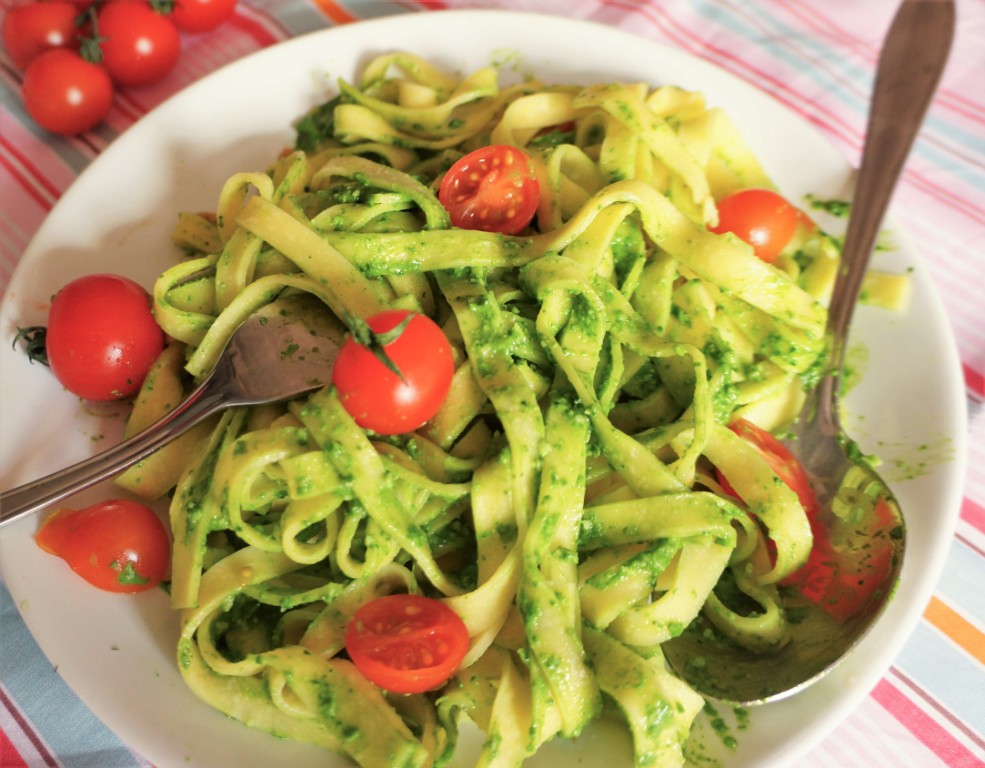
827;0;955;372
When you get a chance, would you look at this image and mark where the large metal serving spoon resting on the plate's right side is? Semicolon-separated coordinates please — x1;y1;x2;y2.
663;0;955;705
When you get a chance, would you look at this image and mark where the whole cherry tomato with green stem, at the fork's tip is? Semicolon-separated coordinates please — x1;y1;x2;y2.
332;310;455;435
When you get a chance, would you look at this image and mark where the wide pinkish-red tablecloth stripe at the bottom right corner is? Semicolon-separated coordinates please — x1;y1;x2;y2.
872;670;985;768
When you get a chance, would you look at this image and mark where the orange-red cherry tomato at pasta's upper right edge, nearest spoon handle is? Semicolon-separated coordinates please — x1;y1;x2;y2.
711;189;800;263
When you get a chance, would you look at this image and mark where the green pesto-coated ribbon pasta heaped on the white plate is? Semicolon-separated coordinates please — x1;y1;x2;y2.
119;52;864;766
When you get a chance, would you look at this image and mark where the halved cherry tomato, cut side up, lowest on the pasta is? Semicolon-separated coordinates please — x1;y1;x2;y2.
345;594;469;693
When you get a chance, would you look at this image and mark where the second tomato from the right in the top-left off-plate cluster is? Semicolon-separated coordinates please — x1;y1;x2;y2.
98;0;181;85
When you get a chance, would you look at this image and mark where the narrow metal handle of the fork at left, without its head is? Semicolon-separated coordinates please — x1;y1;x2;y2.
0;380;225;527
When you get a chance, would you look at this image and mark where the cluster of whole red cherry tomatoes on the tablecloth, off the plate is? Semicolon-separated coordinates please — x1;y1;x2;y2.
2;0;237;136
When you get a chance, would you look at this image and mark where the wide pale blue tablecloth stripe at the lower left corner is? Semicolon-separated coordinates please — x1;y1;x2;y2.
0;583;149;768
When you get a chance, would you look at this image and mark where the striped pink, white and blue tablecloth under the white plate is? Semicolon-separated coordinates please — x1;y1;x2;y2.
0;0;985;768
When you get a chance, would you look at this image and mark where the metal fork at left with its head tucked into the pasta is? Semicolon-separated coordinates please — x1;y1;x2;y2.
0;299;343;526
